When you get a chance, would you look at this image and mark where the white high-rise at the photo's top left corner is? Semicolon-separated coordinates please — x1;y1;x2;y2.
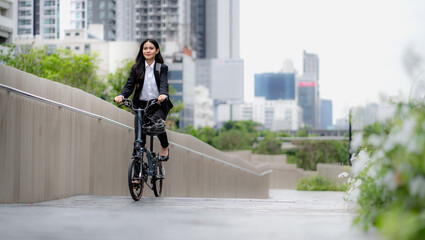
0;0;16;44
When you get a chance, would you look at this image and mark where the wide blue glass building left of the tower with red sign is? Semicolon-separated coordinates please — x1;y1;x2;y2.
255;73;295;100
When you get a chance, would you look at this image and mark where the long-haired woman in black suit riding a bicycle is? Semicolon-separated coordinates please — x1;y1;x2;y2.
115;39;173;161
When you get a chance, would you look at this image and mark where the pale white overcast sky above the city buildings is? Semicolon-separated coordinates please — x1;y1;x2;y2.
240;0;425;120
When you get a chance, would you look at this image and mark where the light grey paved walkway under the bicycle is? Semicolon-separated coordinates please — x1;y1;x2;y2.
0;190;377;240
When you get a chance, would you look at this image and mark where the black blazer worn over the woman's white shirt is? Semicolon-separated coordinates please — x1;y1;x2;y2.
120;62;173;114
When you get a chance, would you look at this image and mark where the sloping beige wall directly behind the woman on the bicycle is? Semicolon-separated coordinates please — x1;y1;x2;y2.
0;64;269;203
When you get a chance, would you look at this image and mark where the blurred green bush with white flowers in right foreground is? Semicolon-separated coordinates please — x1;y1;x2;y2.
348;104;425;240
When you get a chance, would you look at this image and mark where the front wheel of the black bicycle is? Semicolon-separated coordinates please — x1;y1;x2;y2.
128;159;144;201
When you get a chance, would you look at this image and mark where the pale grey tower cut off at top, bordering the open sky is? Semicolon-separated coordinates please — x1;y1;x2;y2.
205;0;239;59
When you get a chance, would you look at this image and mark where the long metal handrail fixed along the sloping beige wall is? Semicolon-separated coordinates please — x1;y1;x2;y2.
0;84;272;176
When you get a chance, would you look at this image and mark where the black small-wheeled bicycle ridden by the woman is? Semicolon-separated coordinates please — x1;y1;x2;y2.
118;98;165;201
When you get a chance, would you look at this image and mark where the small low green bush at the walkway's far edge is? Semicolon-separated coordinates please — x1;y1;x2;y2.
297;174;347;191
